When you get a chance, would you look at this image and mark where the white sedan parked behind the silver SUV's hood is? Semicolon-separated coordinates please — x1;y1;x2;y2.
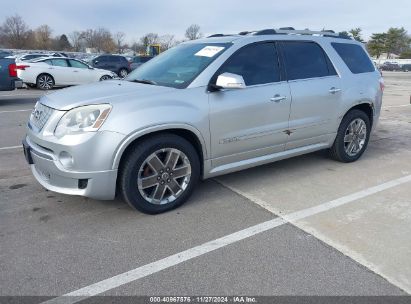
16;57;117;90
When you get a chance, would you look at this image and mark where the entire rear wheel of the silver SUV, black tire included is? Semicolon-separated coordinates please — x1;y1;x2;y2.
330;109;371;163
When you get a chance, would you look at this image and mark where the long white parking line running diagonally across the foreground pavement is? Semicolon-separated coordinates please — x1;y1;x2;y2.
43;175;411;304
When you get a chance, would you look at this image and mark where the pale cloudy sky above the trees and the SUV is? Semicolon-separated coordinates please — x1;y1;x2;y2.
0;0;411;43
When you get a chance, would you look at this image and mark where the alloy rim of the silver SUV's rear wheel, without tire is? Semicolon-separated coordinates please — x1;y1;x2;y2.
344;118;367;156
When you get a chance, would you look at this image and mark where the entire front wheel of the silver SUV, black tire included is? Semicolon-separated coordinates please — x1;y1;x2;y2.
119;134;200;214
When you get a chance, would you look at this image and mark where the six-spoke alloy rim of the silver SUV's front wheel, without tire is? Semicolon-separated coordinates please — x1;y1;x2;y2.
137;148;191;205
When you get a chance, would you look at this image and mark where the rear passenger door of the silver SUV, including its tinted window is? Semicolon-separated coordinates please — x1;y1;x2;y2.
281;41;341;149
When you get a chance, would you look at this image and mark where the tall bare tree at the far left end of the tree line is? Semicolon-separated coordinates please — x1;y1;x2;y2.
0;15;29;49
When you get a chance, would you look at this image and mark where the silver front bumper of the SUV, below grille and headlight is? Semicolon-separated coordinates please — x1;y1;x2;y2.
23;136;117;200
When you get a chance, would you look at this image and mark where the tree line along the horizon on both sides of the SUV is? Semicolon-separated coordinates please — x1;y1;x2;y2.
0;15;411;58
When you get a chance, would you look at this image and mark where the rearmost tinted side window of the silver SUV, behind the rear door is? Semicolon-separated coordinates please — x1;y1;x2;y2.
331;43;375;74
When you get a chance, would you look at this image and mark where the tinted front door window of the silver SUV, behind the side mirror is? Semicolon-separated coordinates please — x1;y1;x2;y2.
218;43;280;86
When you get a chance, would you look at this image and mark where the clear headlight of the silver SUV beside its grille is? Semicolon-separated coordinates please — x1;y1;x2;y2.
54;104;111;137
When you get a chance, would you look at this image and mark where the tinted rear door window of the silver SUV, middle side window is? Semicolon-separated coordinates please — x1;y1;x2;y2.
282;41;335;80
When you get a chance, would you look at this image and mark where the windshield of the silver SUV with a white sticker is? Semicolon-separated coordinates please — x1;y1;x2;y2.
126;43;231;89
